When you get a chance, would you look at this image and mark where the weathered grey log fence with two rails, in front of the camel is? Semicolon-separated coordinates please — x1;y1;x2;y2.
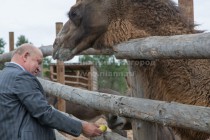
0;0;210;140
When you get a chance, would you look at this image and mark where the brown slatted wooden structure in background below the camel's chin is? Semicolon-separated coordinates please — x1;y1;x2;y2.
50;63;98;91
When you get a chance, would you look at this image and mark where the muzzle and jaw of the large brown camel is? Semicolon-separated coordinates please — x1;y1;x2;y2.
52;10;106;61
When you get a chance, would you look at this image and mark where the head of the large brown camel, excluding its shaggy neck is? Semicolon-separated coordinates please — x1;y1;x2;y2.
53;0;110;61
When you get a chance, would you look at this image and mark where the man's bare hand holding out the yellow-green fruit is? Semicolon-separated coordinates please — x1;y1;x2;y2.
82;122;103;137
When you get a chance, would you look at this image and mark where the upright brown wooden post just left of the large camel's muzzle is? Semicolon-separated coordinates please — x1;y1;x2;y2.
56;22;66;112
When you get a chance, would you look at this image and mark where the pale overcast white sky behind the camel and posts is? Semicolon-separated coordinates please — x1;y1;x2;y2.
0;0;210;52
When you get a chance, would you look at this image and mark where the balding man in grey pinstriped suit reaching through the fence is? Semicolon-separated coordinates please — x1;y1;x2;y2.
0;44;102;140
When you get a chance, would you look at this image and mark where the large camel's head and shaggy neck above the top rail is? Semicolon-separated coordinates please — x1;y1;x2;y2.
53;0;195;61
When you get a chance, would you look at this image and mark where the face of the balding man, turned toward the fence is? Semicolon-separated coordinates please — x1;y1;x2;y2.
25;52;43;76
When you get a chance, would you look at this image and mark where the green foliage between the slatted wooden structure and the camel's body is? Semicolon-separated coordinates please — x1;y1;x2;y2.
79;55;128;93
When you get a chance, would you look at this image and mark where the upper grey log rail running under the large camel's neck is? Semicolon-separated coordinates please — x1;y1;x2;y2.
0;33;210;62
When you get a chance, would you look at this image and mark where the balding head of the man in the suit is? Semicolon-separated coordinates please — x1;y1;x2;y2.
11;44;43;75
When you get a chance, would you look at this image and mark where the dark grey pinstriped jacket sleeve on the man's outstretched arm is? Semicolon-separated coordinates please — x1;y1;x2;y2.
14;72;82;136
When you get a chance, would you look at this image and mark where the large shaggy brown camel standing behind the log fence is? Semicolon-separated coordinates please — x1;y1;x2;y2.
53;0;210;140
